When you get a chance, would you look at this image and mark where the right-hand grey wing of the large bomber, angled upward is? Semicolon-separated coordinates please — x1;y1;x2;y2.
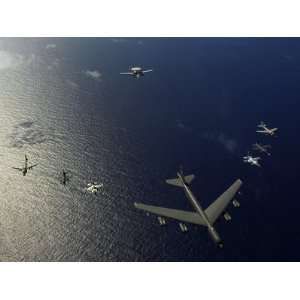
205;179;242;224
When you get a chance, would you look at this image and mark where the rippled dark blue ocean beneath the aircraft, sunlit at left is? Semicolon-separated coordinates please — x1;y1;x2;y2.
0;38;300;261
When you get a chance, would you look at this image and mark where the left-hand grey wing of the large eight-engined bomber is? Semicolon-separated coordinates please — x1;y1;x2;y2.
134;202;206;226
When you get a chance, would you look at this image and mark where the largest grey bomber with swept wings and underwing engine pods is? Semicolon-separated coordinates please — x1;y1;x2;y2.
134;171;242;247
